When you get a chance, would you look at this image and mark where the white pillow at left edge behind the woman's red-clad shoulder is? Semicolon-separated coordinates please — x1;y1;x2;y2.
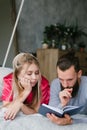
0;67;13;101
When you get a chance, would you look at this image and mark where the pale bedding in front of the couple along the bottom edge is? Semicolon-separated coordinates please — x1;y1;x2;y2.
0;113;87;130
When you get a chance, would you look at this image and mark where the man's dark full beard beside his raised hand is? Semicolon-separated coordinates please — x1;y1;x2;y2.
61;80;79;98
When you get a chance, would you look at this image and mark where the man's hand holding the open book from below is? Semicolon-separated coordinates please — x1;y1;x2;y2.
47;113;72;125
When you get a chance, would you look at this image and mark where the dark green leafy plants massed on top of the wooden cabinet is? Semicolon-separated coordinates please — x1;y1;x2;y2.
44;22;87;49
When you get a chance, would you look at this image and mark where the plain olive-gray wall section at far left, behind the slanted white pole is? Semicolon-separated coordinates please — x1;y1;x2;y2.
0;0;15;67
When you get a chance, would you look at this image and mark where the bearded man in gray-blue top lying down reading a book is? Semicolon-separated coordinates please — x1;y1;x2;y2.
47;51;87;125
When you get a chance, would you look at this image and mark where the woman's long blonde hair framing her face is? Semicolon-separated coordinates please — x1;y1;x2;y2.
13;53;41;107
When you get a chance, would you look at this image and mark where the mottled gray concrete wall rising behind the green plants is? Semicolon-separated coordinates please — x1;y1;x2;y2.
16;0;87;52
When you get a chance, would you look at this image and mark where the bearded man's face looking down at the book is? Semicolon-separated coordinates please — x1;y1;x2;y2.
57;66;81;96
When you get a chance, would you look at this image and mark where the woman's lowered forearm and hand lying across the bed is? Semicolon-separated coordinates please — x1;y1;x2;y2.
4;96;40;120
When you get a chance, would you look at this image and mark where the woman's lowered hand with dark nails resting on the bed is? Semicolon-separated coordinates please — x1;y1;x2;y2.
4;100;23;120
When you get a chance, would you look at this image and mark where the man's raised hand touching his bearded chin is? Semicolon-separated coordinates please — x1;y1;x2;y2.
59;88;72;107
